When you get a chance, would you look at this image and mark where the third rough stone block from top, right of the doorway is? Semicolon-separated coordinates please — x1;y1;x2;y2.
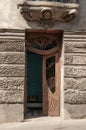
64;66;86;78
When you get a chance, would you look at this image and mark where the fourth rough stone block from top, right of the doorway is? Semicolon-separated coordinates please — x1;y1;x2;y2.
64;78;86;91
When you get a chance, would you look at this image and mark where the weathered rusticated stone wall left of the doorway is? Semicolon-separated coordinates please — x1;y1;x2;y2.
0;30;25;122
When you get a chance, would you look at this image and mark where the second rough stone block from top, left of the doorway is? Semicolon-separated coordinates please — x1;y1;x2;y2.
0;52;25;64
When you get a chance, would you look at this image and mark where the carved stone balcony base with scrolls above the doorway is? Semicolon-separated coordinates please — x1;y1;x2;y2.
19;0;79;28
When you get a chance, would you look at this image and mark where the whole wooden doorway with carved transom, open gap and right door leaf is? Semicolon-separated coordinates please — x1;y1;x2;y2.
25;30;63;116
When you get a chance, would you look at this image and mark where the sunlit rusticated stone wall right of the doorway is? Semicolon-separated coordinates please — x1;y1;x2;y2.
63;32;86;118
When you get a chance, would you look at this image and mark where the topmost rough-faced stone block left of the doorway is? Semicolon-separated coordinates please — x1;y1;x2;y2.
0;40;25;52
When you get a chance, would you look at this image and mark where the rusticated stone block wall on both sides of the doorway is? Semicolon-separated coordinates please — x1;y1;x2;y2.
0;29;86;122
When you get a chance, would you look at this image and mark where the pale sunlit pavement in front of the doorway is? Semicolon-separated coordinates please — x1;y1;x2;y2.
0;117;86;130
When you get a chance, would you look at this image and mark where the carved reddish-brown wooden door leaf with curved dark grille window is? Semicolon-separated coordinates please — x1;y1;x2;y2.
43;53;60;116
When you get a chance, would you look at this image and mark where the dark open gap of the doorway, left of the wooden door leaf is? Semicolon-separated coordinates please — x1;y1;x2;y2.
27;51;43;116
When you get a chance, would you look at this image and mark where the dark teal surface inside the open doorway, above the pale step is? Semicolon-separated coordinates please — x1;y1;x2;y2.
27;52;42;103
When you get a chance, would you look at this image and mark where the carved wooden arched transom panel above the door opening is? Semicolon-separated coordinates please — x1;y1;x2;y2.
26;33;62;55
